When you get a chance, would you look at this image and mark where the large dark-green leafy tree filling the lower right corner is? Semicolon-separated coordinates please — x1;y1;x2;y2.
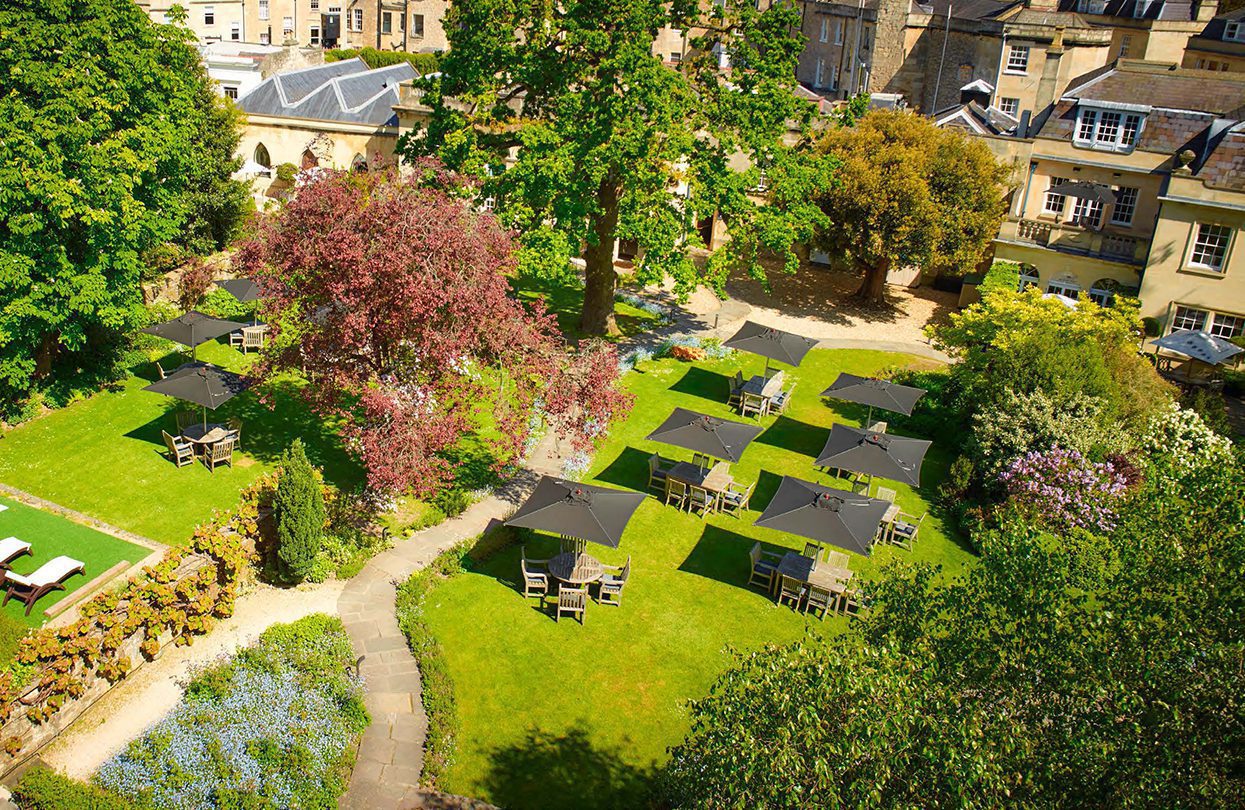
667;448;1245;808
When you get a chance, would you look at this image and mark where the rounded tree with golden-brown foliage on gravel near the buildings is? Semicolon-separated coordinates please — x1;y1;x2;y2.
817;109;1010;302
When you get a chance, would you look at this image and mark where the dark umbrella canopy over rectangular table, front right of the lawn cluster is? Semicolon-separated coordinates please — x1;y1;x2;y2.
752;475;890;555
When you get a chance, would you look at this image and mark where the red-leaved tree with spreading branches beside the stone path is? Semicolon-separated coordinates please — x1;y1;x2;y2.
235;163;630;495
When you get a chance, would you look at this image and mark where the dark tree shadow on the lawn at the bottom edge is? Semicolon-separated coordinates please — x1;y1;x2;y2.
484;726;656;810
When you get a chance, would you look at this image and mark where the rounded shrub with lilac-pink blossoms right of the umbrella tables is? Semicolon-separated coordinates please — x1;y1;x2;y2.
998;447;1128;531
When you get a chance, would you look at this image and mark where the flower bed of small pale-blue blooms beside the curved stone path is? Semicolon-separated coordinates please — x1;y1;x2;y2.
96;616;369;808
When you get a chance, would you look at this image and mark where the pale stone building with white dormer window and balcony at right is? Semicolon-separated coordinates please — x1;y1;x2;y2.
981;60;1245;337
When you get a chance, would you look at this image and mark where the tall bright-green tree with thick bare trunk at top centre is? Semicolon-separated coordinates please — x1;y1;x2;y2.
406;0;830;333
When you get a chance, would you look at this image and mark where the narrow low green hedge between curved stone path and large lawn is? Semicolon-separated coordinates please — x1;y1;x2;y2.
396;529;518;786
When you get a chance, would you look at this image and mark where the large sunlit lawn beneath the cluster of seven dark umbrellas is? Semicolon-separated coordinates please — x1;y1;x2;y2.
426;350;971;808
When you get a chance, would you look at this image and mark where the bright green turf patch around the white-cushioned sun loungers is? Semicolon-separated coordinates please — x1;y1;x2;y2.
0;496;151;642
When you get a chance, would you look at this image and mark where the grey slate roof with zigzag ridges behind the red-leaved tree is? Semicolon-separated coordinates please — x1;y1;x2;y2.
238;58;418;127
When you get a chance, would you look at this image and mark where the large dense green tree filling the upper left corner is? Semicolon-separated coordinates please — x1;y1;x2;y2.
0;0;245;413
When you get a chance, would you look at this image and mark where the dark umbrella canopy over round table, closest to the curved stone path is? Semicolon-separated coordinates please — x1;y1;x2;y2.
505;475;645;549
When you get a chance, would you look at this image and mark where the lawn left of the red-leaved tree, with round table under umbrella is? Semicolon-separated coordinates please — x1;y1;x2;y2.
0;342;361;545
